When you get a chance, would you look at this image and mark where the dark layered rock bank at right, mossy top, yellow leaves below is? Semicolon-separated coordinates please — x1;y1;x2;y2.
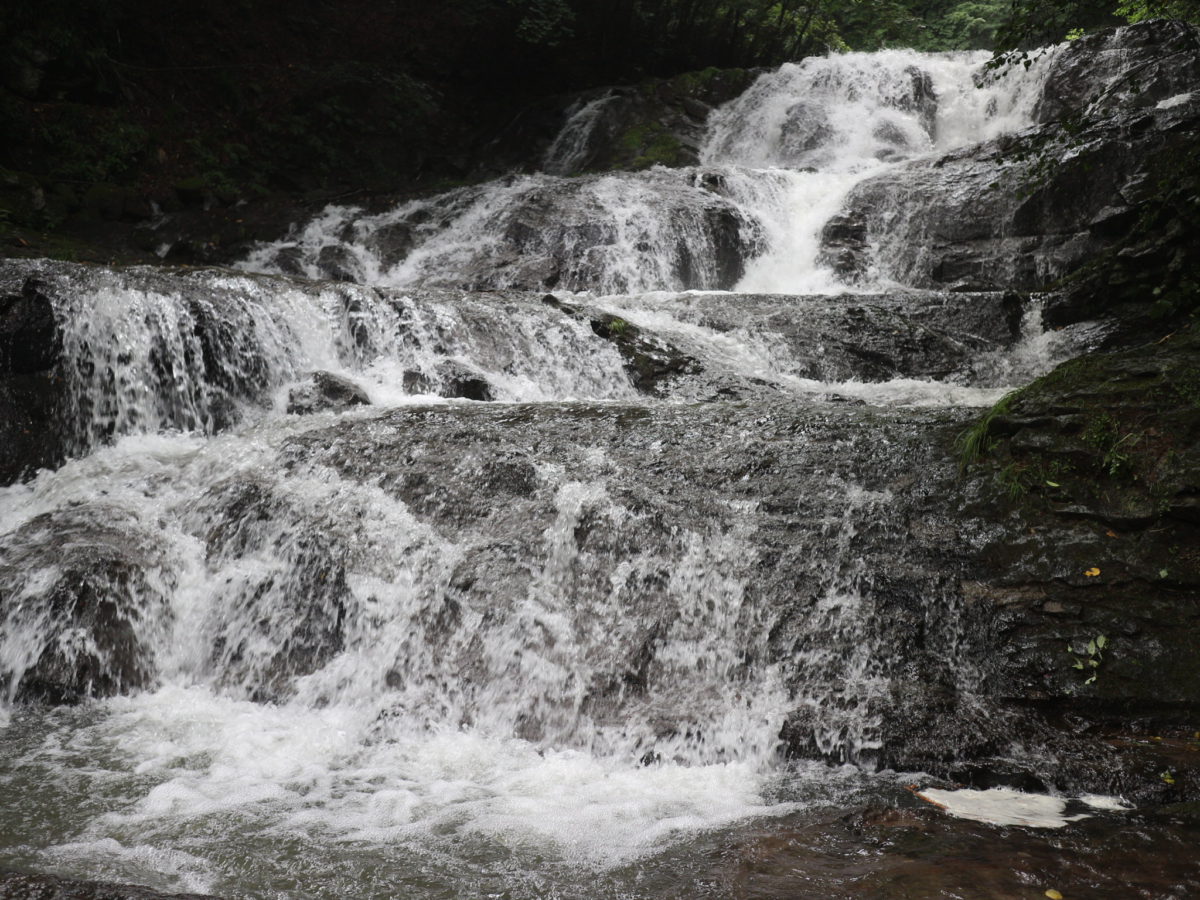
977;329;1200;718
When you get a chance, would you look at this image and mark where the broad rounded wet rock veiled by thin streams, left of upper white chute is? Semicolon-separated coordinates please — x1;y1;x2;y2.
290;170;758;293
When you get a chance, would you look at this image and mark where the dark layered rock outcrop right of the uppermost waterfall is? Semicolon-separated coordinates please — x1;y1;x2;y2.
824;23;1200;290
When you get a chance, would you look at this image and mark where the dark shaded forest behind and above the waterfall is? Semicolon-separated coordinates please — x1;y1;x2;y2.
0;0;1200;247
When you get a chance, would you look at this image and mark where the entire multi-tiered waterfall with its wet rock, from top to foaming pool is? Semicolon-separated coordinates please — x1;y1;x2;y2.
0;40;1087;896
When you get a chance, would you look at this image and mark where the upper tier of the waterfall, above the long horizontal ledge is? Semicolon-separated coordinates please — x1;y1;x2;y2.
241;50;1056;294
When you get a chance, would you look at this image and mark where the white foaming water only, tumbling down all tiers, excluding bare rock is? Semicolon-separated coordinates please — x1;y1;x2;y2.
0;45;1089;895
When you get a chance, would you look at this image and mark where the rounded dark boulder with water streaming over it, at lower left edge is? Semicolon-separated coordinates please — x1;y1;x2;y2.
0;506;167;703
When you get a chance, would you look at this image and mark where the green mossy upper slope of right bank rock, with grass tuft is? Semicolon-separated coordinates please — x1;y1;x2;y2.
956;329;1200;523
